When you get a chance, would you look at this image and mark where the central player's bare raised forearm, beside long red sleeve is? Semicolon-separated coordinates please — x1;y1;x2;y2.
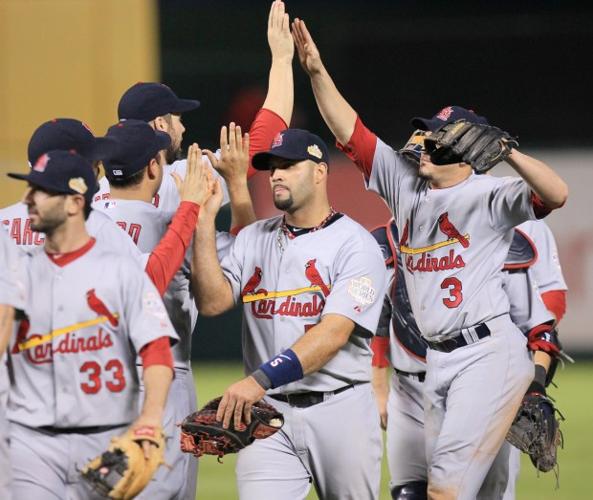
191;211;234;316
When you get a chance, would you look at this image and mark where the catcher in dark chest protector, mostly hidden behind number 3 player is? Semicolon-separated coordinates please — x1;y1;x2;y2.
371;219;561;500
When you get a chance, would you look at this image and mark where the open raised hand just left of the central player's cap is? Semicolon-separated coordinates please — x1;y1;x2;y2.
204;122;249;185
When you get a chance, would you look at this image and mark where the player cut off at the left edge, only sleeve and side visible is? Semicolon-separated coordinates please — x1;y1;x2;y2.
0;231;25;500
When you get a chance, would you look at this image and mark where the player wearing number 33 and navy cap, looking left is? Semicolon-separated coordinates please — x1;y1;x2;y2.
8;151;177;499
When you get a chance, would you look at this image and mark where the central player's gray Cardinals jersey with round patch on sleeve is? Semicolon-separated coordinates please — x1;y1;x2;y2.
221;216;385;393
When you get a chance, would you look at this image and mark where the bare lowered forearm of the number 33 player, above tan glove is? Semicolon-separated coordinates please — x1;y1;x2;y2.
137;365;173;426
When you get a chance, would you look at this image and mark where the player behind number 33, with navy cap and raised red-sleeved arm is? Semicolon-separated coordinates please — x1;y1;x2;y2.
0;118;204;294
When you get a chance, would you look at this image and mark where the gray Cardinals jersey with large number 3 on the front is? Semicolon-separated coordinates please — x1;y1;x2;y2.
368;143;535;341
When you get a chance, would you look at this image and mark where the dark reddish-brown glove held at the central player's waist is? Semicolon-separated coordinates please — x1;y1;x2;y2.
181;398;284;461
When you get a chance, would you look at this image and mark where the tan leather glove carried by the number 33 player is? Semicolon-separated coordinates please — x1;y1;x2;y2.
81;427;165;500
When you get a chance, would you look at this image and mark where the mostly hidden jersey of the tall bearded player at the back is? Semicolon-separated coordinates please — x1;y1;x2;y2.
94;155;230;212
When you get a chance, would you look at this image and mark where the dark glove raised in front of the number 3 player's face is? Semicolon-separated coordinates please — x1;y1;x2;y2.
424;120;519;174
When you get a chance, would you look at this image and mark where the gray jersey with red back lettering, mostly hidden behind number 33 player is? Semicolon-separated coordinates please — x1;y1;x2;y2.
0;202;143;268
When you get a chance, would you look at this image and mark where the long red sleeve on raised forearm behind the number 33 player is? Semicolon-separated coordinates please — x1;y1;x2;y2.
145;201;200;295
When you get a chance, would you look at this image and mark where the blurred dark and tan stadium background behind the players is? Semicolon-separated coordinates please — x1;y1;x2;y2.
0;0;593;360
